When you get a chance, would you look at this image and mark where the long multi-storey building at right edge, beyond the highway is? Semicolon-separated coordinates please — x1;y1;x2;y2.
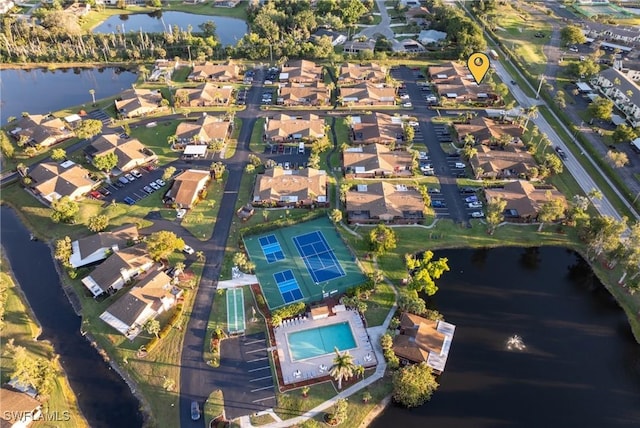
591;68;640;128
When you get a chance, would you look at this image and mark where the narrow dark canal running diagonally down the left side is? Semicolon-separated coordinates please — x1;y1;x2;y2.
0;206;143;428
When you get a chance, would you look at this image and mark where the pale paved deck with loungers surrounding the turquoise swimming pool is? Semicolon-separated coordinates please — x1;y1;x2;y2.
274;310;378;385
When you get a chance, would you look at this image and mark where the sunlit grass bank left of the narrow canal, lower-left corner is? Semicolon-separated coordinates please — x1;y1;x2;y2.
0;259;89;428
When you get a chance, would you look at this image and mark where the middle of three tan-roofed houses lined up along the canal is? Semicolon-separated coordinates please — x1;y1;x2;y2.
82;244;154;298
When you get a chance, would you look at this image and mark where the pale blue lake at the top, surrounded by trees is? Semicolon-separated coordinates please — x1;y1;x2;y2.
93;12;248;46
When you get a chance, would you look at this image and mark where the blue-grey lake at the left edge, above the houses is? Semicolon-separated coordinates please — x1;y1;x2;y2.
0;67;137;125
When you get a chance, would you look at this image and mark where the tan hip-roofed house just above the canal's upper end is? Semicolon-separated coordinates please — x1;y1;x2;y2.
29;160;98;203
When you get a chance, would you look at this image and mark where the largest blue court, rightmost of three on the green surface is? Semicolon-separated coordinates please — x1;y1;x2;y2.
293;230;346;284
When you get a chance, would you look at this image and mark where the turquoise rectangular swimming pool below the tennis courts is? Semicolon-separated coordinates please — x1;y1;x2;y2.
287;322;356;361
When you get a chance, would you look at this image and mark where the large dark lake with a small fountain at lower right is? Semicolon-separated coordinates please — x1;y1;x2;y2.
371;248;640;428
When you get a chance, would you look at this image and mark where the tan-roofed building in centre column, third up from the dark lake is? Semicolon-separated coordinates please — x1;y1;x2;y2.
350;113;404;144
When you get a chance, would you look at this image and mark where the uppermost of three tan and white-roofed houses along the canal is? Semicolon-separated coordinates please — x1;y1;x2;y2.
69;224;138;268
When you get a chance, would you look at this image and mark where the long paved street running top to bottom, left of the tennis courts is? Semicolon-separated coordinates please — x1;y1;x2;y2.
180;68;270;427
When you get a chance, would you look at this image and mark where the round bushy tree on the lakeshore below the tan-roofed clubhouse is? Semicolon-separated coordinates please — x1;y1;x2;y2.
392;363;439;407
